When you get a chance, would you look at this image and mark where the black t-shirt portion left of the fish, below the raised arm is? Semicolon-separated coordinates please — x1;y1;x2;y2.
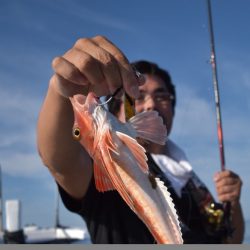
59;175;155;244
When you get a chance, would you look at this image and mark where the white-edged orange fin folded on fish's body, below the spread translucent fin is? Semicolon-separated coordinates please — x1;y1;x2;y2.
116;132;148;173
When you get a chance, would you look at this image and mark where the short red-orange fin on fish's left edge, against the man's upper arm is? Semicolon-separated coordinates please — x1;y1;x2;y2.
94;163;115;192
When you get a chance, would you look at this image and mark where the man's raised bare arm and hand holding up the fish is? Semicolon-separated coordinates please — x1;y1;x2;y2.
37;36;139;199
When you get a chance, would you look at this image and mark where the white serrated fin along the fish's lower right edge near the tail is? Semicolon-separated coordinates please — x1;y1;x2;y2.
155;178;183;244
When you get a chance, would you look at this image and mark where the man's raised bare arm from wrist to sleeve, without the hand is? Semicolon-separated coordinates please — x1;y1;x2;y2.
37;77;92;199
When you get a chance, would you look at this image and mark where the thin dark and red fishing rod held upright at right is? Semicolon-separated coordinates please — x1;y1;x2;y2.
207;0;232;236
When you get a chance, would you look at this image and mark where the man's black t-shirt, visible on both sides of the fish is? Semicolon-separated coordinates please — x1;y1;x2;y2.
59;156;221;244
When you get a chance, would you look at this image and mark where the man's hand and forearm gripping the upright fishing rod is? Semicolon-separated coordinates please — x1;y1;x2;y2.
214;170;245;244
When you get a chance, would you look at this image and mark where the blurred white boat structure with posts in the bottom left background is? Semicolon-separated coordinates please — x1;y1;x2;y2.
0;165;91;244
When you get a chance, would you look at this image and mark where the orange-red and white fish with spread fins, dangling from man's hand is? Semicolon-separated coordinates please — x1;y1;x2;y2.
70;92;183;244
